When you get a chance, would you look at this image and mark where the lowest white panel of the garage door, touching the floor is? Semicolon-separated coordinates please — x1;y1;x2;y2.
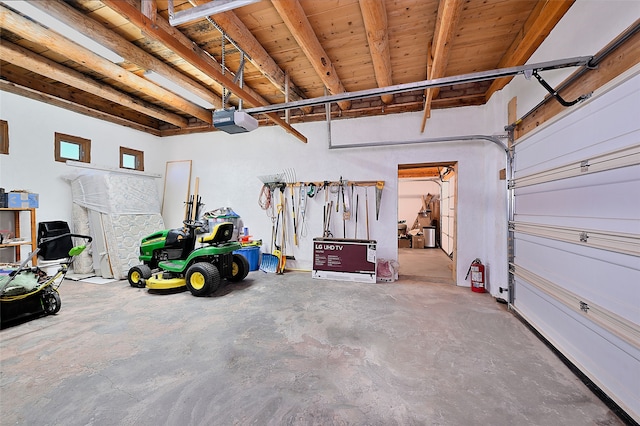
516;280;640;413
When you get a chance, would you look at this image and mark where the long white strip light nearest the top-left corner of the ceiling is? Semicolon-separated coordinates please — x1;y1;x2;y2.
1;0;124;64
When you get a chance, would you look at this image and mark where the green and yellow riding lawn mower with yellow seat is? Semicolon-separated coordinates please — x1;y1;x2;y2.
128;196;249;296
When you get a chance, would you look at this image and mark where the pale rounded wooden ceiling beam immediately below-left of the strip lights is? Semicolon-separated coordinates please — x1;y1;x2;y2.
0;6;213;125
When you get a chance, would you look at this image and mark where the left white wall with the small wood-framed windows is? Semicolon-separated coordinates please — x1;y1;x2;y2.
0;92;167;255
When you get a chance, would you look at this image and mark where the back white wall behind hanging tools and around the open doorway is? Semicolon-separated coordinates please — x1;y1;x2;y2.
158;107;506;288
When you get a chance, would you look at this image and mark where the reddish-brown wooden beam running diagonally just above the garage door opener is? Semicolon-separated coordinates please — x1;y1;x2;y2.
103;0;307;143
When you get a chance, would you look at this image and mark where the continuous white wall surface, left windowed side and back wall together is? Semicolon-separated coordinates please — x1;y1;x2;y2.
0;92;520;296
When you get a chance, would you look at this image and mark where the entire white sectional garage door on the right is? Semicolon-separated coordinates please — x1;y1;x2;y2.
509;67;640;421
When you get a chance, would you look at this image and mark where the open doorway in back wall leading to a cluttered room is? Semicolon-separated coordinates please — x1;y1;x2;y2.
398;161;458;284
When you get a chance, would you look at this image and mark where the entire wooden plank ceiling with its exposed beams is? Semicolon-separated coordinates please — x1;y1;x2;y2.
0;0;574;141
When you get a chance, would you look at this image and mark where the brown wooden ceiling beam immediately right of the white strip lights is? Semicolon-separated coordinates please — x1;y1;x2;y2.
32;0;222;108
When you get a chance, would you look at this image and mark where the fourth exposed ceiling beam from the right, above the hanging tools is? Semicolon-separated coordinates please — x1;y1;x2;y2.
271;0;351;110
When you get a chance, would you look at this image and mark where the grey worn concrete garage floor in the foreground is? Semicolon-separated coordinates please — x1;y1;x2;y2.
0;271;622;426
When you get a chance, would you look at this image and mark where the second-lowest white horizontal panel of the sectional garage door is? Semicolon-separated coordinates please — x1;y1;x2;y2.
515;235;640;323
